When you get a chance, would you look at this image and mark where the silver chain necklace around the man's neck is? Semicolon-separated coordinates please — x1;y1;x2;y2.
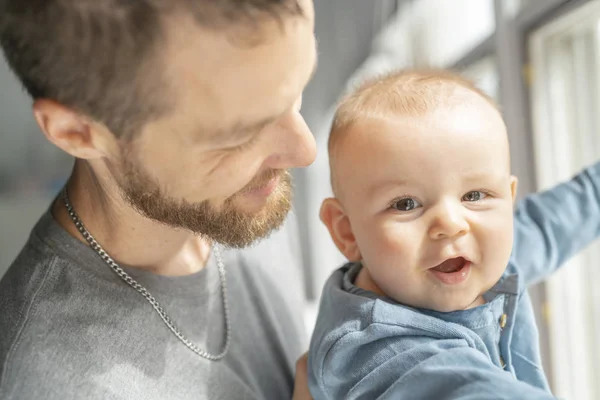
62;187;231;361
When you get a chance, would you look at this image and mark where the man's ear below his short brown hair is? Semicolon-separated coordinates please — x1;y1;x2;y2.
33;99;116;160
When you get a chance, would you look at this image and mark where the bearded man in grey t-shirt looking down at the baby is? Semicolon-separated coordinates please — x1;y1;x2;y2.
0;0;316;400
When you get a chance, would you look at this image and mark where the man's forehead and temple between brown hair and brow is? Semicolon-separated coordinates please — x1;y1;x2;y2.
158;7;316;140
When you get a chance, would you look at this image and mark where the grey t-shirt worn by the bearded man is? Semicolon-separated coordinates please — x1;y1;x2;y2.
0;209;307;400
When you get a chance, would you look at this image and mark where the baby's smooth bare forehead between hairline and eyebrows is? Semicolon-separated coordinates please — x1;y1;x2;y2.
330;103;508;175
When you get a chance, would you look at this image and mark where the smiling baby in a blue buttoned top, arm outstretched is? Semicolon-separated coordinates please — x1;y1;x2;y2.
309;71;600;400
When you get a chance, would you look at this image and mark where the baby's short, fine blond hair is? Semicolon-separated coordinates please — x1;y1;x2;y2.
328;69;498;194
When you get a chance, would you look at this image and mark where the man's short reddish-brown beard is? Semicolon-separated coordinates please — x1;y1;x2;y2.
120;162;292;248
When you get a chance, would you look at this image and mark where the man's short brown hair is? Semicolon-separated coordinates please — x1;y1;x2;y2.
0;0;302;136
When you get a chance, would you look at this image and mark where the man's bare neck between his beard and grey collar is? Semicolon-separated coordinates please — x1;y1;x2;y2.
52;161;211;276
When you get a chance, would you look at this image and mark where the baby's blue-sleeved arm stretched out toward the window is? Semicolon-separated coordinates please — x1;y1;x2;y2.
511;163;600;285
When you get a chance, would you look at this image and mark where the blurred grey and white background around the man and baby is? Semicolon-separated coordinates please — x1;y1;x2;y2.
0;0;600;400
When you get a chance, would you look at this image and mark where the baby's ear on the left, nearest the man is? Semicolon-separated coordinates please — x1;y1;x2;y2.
319;198;362;261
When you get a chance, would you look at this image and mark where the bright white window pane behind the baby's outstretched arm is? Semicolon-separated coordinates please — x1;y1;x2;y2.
529;1;600;400
